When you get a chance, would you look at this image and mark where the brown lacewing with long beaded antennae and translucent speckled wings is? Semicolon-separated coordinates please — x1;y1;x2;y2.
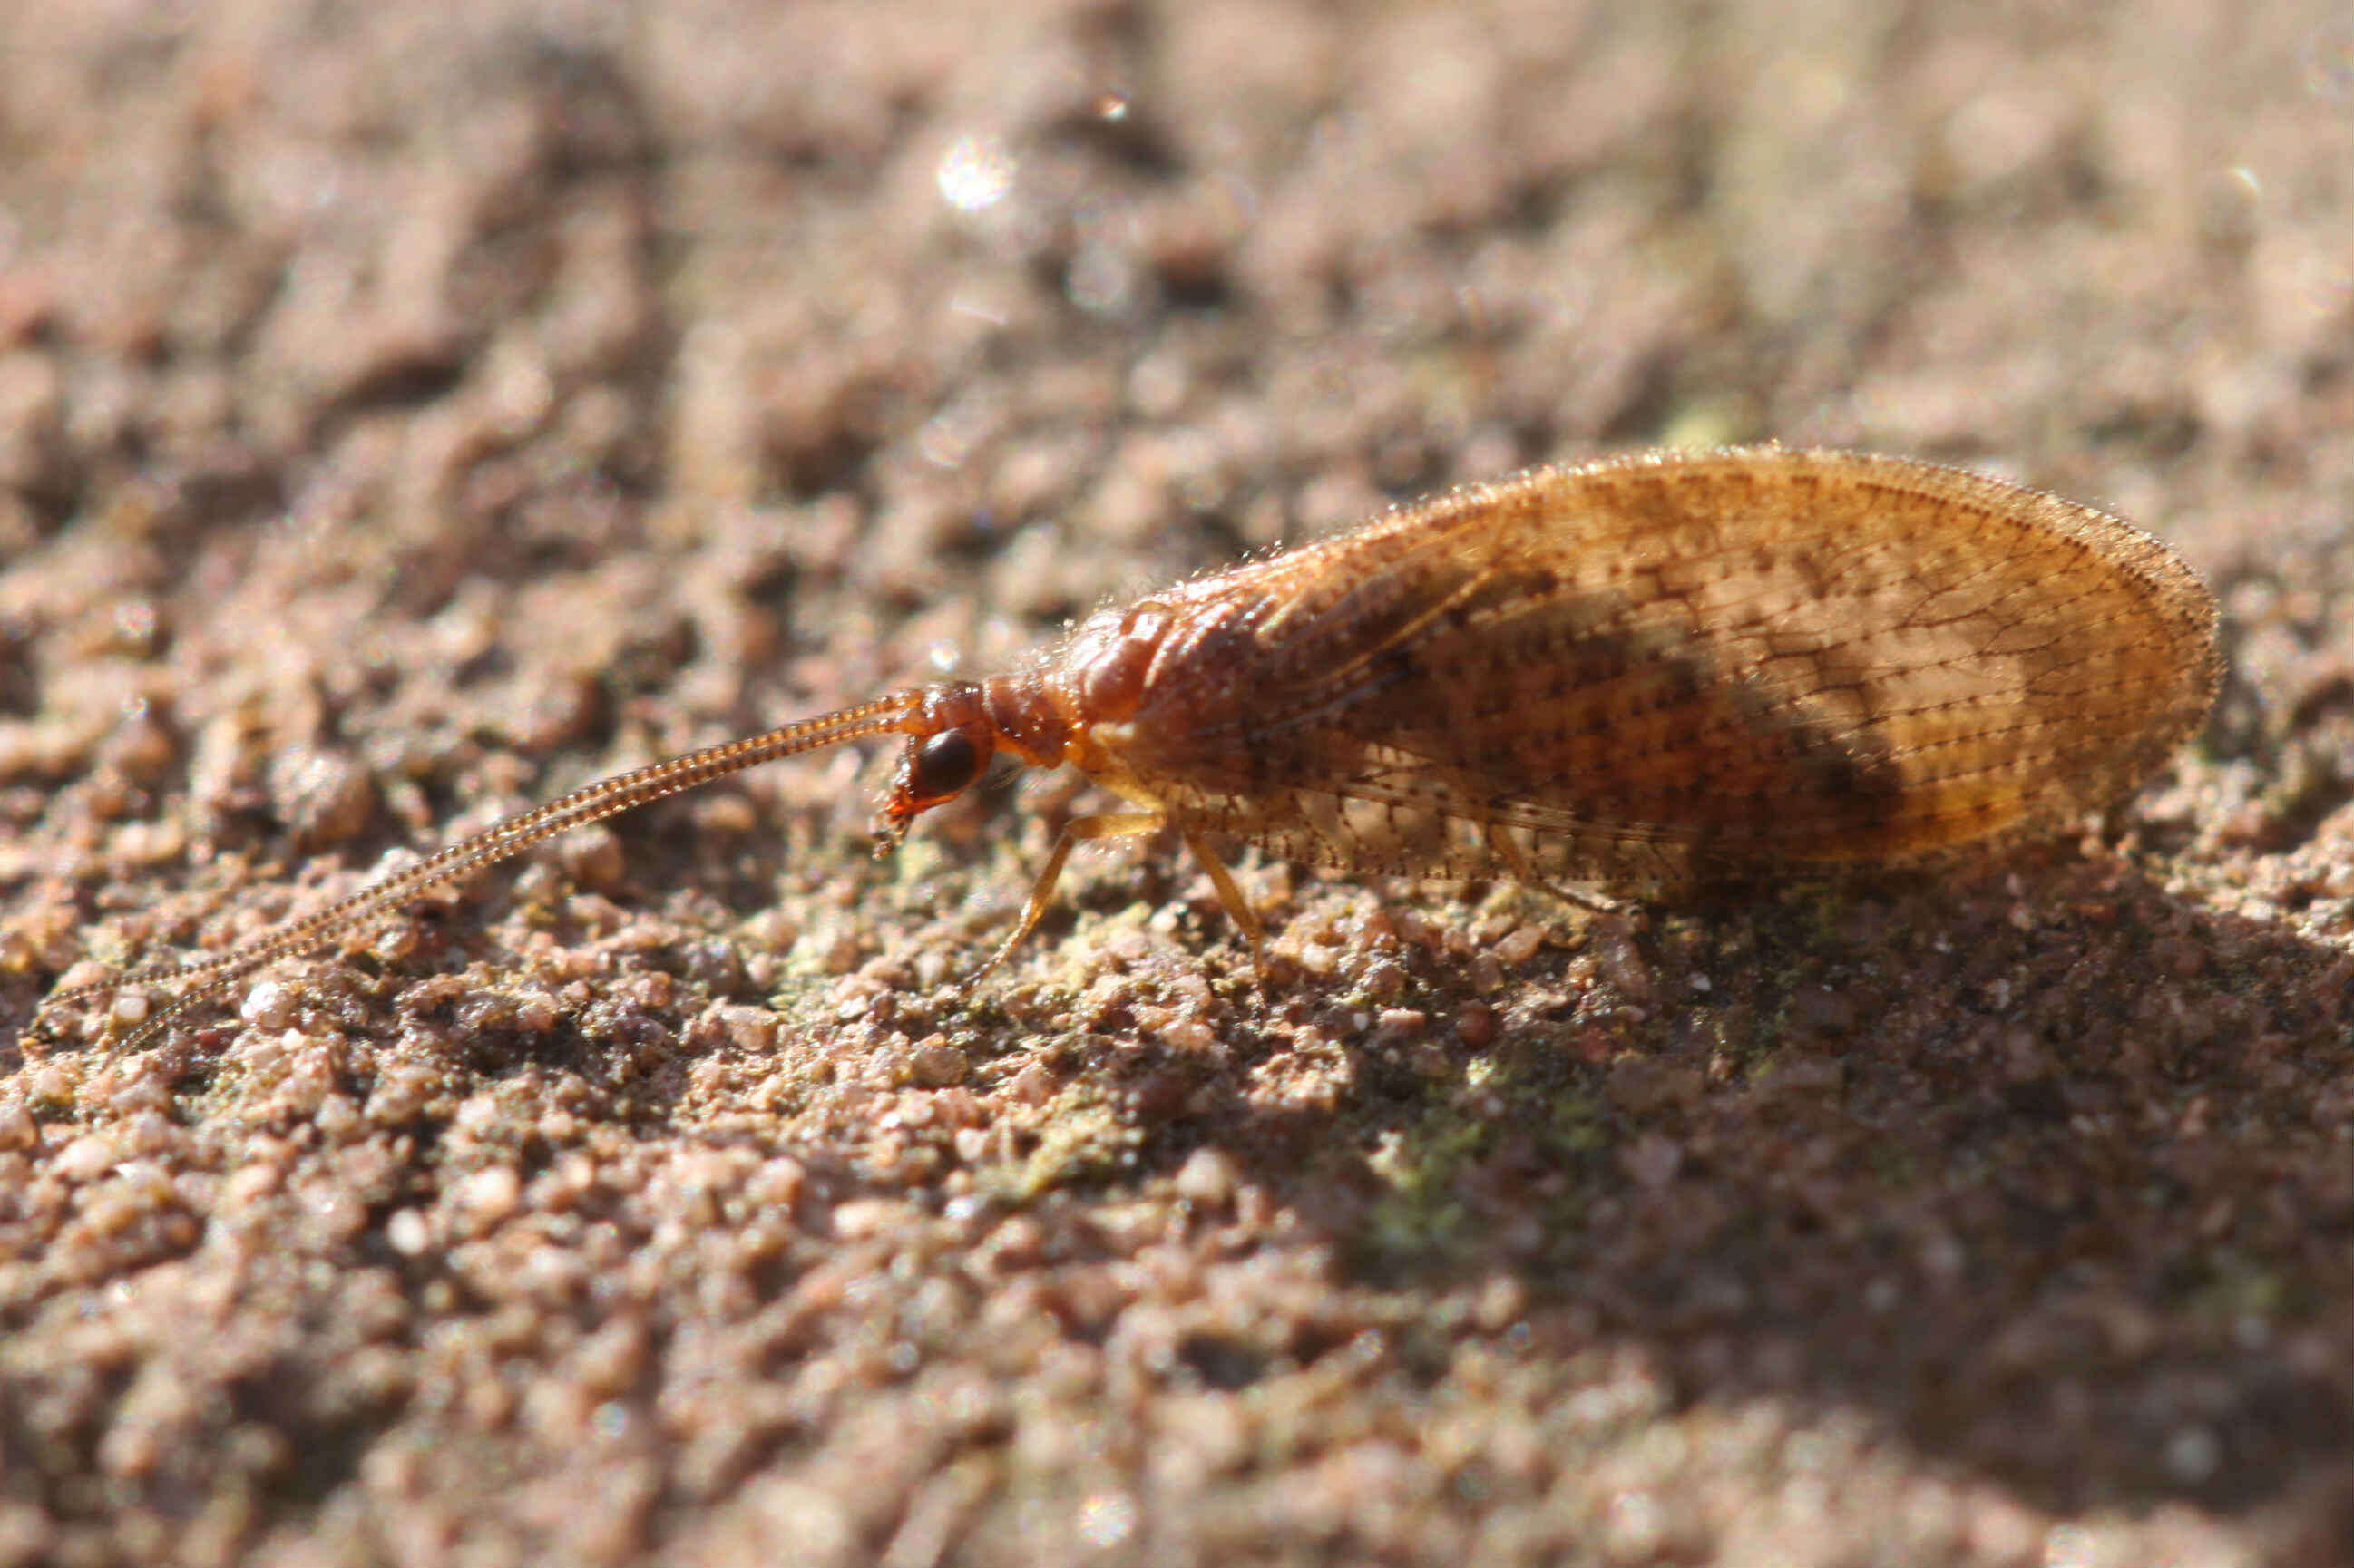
36;447;2217;1040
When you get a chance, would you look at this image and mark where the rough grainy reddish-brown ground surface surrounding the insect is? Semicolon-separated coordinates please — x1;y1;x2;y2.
0;0;2354;1565
